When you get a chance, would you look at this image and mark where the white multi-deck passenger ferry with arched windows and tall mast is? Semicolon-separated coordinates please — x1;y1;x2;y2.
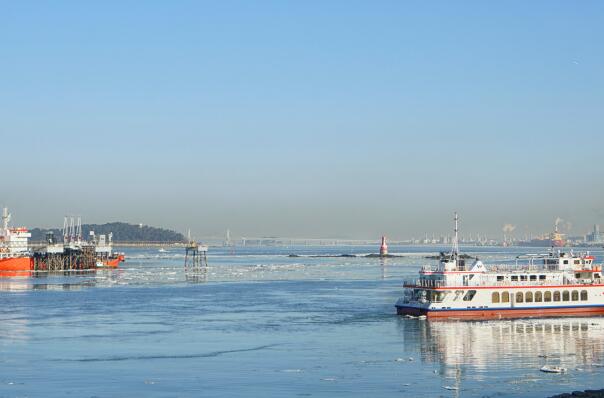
396;213;604;319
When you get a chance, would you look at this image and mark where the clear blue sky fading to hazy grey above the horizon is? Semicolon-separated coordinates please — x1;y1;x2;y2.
0;0;604;239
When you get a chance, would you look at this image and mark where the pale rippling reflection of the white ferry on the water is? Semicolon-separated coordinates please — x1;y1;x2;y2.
399;317;604;387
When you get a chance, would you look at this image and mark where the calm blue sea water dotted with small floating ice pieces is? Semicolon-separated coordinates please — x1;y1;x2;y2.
0;246;604;397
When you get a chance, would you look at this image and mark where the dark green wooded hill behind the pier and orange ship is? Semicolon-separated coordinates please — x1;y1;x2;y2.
30;222;185;242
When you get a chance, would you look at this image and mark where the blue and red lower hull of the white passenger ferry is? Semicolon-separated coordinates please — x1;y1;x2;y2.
396;305;604;319
